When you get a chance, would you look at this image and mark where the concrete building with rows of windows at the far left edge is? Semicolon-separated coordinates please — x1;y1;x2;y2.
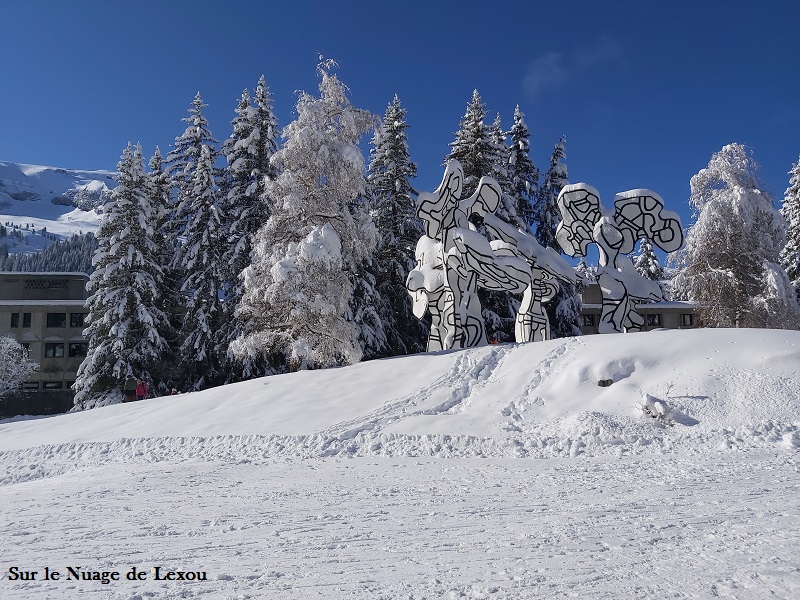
0;272;89;414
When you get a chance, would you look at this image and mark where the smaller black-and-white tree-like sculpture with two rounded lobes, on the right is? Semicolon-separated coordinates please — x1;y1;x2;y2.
556;183;683;333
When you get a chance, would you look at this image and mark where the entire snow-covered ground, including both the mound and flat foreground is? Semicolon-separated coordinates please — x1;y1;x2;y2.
0;329;800;600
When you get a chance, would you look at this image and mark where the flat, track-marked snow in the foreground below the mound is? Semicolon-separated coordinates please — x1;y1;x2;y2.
0;451;800;600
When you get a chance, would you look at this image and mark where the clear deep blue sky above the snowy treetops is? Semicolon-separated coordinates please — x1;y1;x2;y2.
0;0;800;230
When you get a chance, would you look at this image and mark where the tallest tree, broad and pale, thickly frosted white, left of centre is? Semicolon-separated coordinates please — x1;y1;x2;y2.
232;60;376;370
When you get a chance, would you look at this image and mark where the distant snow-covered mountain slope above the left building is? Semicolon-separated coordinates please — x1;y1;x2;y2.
0;161;117;252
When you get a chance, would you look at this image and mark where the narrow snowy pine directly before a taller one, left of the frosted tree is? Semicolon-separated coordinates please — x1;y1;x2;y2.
177;145;227;390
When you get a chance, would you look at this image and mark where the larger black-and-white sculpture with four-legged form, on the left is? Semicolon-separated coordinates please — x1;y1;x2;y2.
406;160;577;351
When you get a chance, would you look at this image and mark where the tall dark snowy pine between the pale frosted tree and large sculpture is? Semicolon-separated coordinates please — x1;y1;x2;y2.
361;96;428;357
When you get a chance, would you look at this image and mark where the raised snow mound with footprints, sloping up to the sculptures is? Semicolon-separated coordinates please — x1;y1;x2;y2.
0;329;800;484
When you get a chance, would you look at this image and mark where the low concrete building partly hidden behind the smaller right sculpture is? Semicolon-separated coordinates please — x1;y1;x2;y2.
581;283;701;335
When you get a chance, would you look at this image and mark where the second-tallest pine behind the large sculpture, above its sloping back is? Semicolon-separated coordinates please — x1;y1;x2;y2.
508;105;539;231
